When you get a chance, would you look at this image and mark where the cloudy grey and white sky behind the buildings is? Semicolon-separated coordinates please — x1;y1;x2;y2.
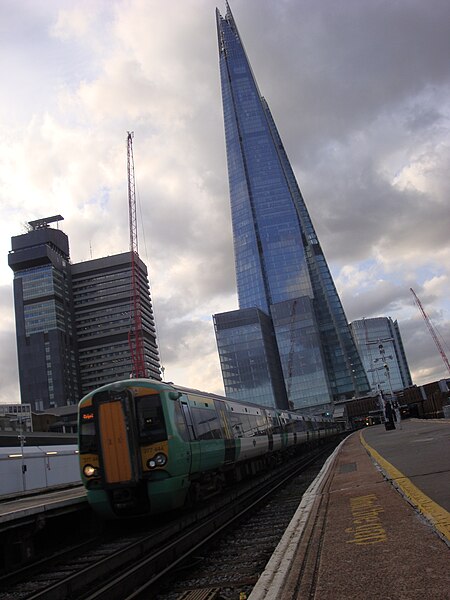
0;0;450;402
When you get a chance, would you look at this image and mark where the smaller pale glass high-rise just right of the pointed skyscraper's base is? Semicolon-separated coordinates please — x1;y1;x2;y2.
350;317;412;394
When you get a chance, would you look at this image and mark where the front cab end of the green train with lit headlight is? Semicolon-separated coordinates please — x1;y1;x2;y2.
80;385;190;519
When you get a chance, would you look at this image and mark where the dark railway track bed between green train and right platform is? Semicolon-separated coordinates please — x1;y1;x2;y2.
0;440;338;600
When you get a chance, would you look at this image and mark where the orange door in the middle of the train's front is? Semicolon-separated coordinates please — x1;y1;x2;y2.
93;391;138;485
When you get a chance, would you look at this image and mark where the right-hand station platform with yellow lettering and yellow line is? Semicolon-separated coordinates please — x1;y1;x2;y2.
248;419;450;600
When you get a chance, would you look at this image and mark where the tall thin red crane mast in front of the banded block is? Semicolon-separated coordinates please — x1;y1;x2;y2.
127;131;147;377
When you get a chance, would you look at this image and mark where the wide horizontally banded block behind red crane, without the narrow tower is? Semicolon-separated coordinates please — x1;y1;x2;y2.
71;252;161;396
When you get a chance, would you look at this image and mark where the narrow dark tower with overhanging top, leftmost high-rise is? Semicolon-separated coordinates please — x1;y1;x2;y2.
8;215;81;411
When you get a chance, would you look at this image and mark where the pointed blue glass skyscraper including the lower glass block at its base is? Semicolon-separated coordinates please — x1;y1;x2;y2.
214;4;369;412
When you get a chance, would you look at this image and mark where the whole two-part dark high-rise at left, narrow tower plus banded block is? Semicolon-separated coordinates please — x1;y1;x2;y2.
8;215;161;411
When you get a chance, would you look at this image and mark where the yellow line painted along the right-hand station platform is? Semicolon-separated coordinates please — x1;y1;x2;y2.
359;431;450;544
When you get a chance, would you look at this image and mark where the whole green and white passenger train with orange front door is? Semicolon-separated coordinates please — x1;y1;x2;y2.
78;379;341;520
